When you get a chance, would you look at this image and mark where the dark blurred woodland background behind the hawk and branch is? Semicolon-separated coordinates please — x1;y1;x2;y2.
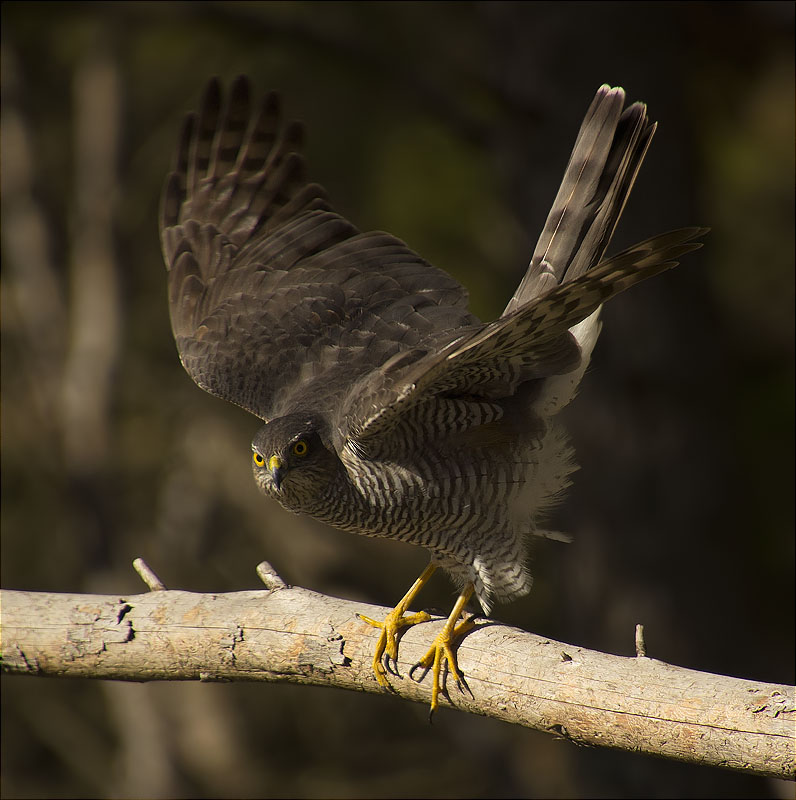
2;2;794;798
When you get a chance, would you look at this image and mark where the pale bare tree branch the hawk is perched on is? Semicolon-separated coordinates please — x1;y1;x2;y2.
0;565;796;780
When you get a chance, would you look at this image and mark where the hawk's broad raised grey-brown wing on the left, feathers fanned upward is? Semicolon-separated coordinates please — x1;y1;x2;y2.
160;77;478;419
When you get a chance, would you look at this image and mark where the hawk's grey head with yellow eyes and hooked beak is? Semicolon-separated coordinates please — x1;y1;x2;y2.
252;414;340;510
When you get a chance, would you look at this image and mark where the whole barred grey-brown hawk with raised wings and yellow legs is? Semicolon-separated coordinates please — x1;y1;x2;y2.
160;77;705;713
